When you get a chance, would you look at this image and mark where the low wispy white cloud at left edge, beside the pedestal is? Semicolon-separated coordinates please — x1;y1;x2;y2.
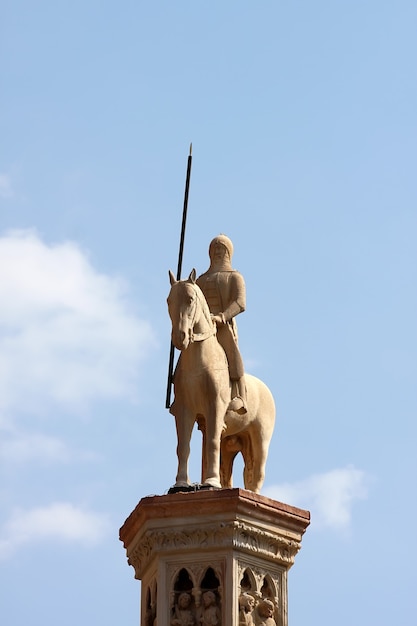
0;502;110;558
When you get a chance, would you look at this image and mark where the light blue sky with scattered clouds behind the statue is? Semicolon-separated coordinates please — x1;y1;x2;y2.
0;0;417;626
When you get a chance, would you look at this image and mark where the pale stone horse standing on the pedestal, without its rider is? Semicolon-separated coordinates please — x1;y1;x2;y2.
167;270;275;493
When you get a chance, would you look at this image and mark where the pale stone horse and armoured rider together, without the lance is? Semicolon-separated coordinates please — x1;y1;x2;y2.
167;235;275;493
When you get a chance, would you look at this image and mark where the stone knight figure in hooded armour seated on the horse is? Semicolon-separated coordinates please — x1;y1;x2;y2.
197;235;247;415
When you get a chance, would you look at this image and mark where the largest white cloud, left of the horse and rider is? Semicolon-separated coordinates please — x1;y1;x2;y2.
0;231;154;420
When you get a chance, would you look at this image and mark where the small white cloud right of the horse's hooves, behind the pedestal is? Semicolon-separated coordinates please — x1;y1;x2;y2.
262;466;368;530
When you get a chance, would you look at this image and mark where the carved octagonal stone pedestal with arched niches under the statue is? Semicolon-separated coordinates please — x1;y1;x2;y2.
120;489;310;626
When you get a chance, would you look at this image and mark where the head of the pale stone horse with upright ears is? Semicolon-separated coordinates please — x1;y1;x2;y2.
167;269;214;350
